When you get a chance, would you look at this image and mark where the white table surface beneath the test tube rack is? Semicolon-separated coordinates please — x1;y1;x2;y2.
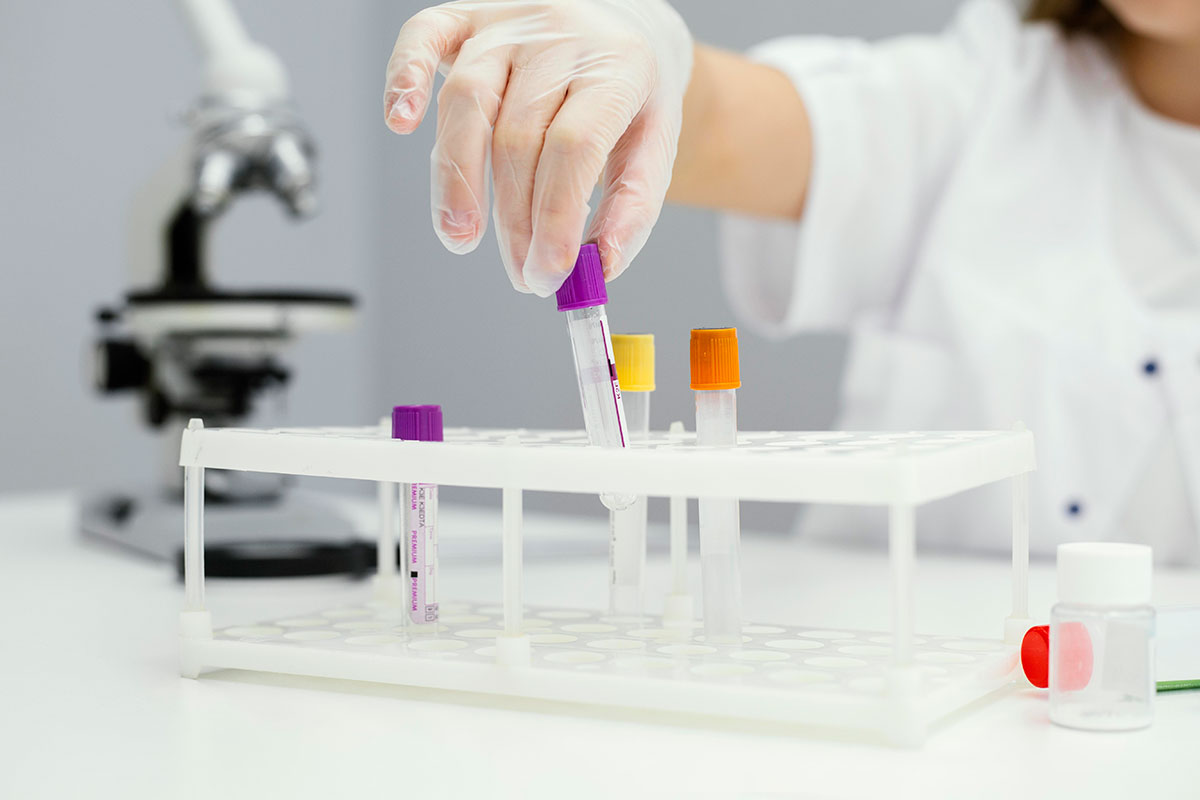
0;495;1200;800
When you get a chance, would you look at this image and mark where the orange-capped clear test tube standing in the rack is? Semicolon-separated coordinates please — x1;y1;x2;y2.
691;327;742;644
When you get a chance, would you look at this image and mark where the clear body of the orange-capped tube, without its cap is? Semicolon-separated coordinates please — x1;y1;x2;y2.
696;389;742;643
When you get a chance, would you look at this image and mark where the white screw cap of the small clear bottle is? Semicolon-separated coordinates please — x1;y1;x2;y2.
1058;542;1153;606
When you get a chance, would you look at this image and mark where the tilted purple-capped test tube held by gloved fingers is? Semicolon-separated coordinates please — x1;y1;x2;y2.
557;245;636;511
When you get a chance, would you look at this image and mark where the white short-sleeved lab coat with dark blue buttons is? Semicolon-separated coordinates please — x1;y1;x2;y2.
722;0;1200;561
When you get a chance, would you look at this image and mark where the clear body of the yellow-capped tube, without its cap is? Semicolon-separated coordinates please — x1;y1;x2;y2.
608;391;650;616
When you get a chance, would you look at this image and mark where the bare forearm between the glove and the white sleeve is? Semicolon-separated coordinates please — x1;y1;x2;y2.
667;44;812;219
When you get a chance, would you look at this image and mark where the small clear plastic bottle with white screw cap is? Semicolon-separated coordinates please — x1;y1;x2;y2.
1049;542;1154;730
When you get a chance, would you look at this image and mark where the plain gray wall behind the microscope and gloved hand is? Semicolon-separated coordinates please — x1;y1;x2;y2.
0;0;974;525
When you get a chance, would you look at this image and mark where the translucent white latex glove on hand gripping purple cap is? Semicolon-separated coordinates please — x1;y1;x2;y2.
384;0;692;296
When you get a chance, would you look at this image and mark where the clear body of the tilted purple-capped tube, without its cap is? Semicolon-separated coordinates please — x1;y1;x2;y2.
564;306;637;511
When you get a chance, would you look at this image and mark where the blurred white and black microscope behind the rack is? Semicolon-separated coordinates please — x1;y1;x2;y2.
83;0;361;576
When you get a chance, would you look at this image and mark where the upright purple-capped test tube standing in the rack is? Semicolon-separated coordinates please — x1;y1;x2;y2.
391;405;442;626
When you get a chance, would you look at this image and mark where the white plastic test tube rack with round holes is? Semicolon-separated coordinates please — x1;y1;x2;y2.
180;420;1034;746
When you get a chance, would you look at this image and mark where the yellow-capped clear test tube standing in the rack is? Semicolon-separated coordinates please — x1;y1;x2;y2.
608;333;654;616
